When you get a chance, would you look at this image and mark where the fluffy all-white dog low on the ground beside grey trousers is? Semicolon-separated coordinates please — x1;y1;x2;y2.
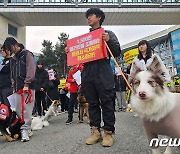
31;117;49;130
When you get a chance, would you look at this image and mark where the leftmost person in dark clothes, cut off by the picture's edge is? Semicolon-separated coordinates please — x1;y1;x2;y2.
0;46;13;106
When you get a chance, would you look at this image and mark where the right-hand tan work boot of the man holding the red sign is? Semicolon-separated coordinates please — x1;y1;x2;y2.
101;130;113;147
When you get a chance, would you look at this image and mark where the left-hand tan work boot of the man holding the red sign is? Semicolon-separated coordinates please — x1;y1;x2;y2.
86;127;102;145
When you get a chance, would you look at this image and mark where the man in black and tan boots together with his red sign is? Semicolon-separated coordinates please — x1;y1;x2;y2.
65;8;121;147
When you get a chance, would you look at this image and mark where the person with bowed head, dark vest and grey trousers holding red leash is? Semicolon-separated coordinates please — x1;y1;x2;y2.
3;37;36;142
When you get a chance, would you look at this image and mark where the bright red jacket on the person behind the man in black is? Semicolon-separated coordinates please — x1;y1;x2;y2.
67;66;79;93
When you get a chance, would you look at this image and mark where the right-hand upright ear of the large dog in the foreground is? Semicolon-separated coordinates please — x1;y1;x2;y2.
147;56;164;81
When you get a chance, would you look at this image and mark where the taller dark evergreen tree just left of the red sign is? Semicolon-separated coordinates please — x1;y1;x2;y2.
54;33;69;75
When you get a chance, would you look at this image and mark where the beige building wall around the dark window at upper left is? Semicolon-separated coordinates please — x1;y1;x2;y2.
0;15;26;46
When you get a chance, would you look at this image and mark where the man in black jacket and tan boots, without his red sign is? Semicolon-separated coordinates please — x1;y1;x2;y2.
82;8;121;147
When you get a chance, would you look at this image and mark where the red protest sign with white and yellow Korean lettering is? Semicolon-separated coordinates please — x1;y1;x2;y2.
67;28;107;66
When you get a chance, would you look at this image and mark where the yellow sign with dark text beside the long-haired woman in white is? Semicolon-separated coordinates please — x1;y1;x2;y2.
124;48;139;65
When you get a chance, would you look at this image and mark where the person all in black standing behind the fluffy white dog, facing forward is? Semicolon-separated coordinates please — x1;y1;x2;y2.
35;61;49;117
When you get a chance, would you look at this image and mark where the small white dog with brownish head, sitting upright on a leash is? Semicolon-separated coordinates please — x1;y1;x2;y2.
42;100;61;121
